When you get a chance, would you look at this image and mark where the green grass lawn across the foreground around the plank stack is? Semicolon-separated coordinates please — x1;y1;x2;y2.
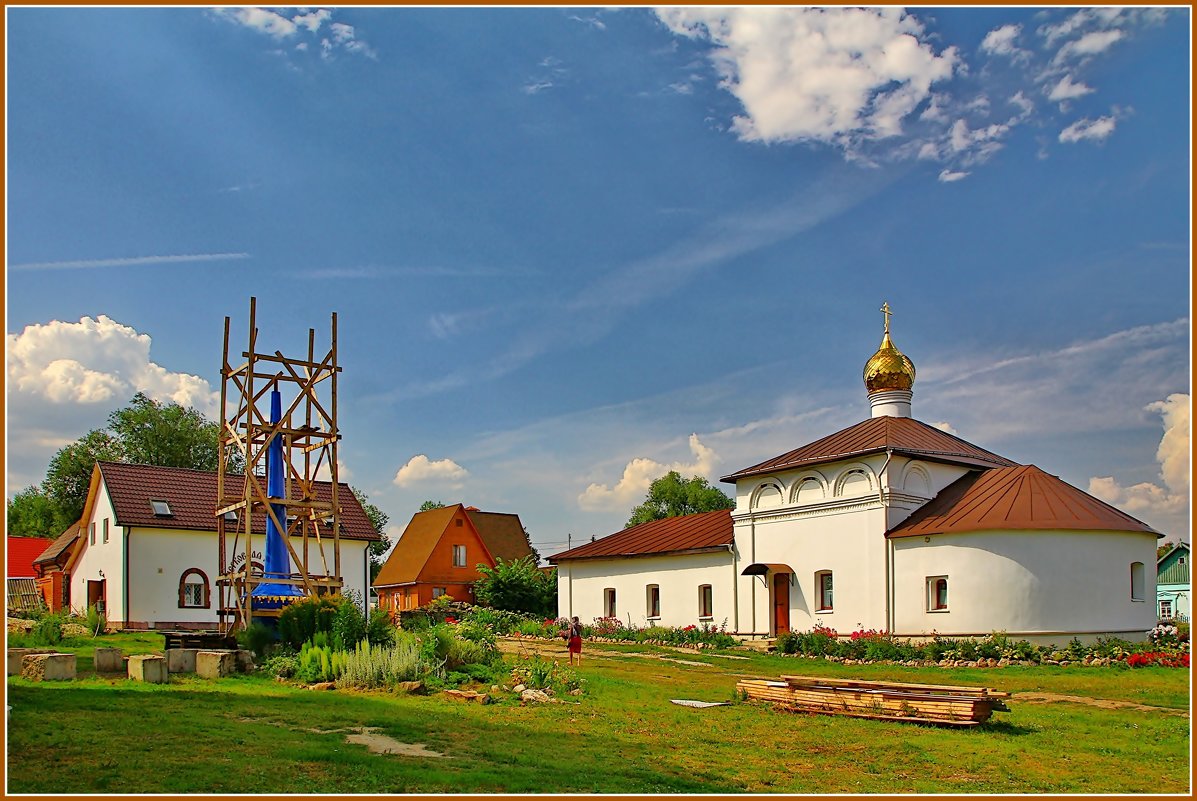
7;635;1190;794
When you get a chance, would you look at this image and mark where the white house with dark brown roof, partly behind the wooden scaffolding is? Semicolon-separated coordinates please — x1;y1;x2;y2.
63;462;378;629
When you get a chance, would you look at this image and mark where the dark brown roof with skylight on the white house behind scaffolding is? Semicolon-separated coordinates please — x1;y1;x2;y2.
96;462;379;540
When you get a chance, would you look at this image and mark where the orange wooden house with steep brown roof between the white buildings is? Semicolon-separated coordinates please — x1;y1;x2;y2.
373;504;531;612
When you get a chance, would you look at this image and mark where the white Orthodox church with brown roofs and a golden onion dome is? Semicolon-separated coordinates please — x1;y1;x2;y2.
549;304;1162;642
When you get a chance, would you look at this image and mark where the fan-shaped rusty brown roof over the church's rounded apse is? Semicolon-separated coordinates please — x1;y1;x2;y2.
886;465;1156;538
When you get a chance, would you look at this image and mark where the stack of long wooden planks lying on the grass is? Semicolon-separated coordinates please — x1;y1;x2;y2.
736;675;1010;727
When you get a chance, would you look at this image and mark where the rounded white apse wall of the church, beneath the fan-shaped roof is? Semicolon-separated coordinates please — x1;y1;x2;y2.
893;532;1156;639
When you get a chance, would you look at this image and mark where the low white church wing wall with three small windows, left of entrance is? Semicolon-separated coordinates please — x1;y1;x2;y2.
557;551;735;630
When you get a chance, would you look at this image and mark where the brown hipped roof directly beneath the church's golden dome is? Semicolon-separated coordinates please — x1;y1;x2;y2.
721;417;1016;484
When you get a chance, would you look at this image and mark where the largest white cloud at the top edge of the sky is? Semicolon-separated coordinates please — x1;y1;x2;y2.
656;7;959;150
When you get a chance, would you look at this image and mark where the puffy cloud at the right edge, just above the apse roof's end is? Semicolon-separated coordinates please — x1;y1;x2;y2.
1089;393;1191;536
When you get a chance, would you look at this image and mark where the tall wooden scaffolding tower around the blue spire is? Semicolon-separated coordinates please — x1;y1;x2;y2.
215;297;342;632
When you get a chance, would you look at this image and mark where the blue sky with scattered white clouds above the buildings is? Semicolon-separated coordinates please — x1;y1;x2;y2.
6;7;1191;554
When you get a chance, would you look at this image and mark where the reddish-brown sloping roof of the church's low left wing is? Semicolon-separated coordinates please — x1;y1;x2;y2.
548;509;734;564
